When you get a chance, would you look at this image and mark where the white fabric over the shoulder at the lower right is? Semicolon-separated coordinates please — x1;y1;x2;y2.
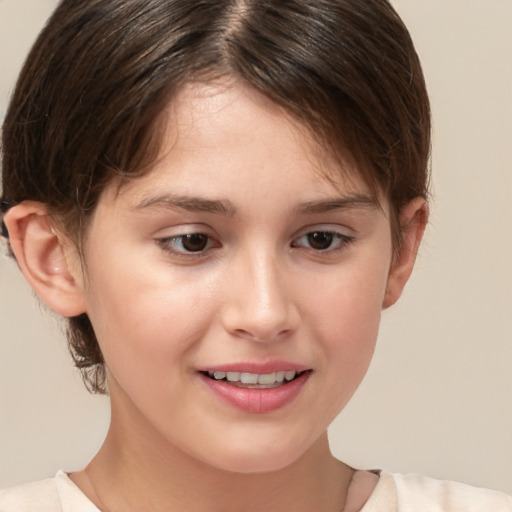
372;472;512;512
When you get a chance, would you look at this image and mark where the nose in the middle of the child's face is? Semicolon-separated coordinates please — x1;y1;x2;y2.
222;253;300;342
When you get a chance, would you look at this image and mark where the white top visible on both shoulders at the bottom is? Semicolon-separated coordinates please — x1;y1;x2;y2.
0;471;512;512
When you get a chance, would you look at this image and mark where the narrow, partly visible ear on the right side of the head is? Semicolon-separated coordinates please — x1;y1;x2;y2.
382;197;428;308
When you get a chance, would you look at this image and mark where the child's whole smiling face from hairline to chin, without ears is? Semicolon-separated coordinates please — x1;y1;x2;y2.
78;81;392;472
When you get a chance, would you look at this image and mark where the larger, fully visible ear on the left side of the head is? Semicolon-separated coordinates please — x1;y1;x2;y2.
4;201;86;317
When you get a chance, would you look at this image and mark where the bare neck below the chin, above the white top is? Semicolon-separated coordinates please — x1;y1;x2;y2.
72;420;353;512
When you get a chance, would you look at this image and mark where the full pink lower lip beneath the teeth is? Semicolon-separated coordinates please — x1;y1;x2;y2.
200;371;311;413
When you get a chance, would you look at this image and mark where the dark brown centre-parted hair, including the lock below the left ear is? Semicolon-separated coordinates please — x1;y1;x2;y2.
2;0;430;393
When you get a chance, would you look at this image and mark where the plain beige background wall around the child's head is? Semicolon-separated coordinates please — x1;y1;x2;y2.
0;0;512;494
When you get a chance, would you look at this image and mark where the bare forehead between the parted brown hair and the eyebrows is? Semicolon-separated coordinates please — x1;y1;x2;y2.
107;77;380;210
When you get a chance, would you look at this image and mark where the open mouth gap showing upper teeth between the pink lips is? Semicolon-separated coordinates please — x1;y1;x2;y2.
201;370;311;389
